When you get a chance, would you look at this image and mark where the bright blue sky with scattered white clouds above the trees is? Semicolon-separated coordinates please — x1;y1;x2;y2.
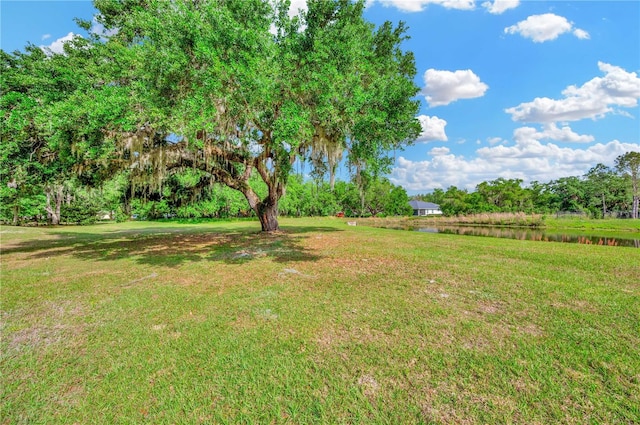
0;0;640;194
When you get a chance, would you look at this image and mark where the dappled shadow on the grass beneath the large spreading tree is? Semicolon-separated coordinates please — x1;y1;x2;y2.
2;225;340;267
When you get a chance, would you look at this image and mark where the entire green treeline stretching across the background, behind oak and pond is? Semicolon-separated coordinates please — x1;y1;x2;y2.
0;152;640;224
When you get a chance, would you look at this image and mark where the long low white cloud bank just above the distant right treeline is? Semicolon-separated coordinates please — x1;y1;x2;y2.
390;140;640;193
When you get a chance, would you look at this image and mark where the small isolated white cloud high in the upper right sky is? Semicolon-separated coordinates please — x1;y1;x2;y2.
504;13;589;43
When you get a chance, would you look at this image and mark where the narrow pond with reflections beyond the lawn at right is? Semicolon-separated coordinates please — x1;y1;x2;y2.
384;226;640;248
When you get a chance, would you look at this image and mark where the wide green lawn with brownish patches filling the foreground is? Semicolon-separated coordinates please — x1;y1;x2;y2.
0;219;640;424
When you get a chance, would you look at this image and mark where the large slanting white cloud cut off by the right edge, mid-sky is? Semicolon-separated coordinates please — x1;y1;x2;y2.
505;62;640;123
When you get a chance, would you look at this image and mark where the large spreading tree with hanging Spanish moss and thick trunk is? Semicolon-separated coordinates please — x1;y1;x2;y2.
3;0;420;231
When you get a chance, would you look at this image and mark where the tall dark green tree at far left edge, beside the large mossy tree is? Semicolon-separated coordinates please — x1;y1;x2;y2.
0;44;96;224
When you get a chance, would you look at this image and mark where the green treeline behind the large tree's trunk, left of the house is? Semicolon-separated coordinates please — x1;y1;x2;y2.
0;170;412;225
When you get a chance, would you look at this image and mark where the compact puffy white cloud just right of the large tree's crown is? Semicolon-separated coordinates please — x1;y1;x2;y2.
422;69;489;106
